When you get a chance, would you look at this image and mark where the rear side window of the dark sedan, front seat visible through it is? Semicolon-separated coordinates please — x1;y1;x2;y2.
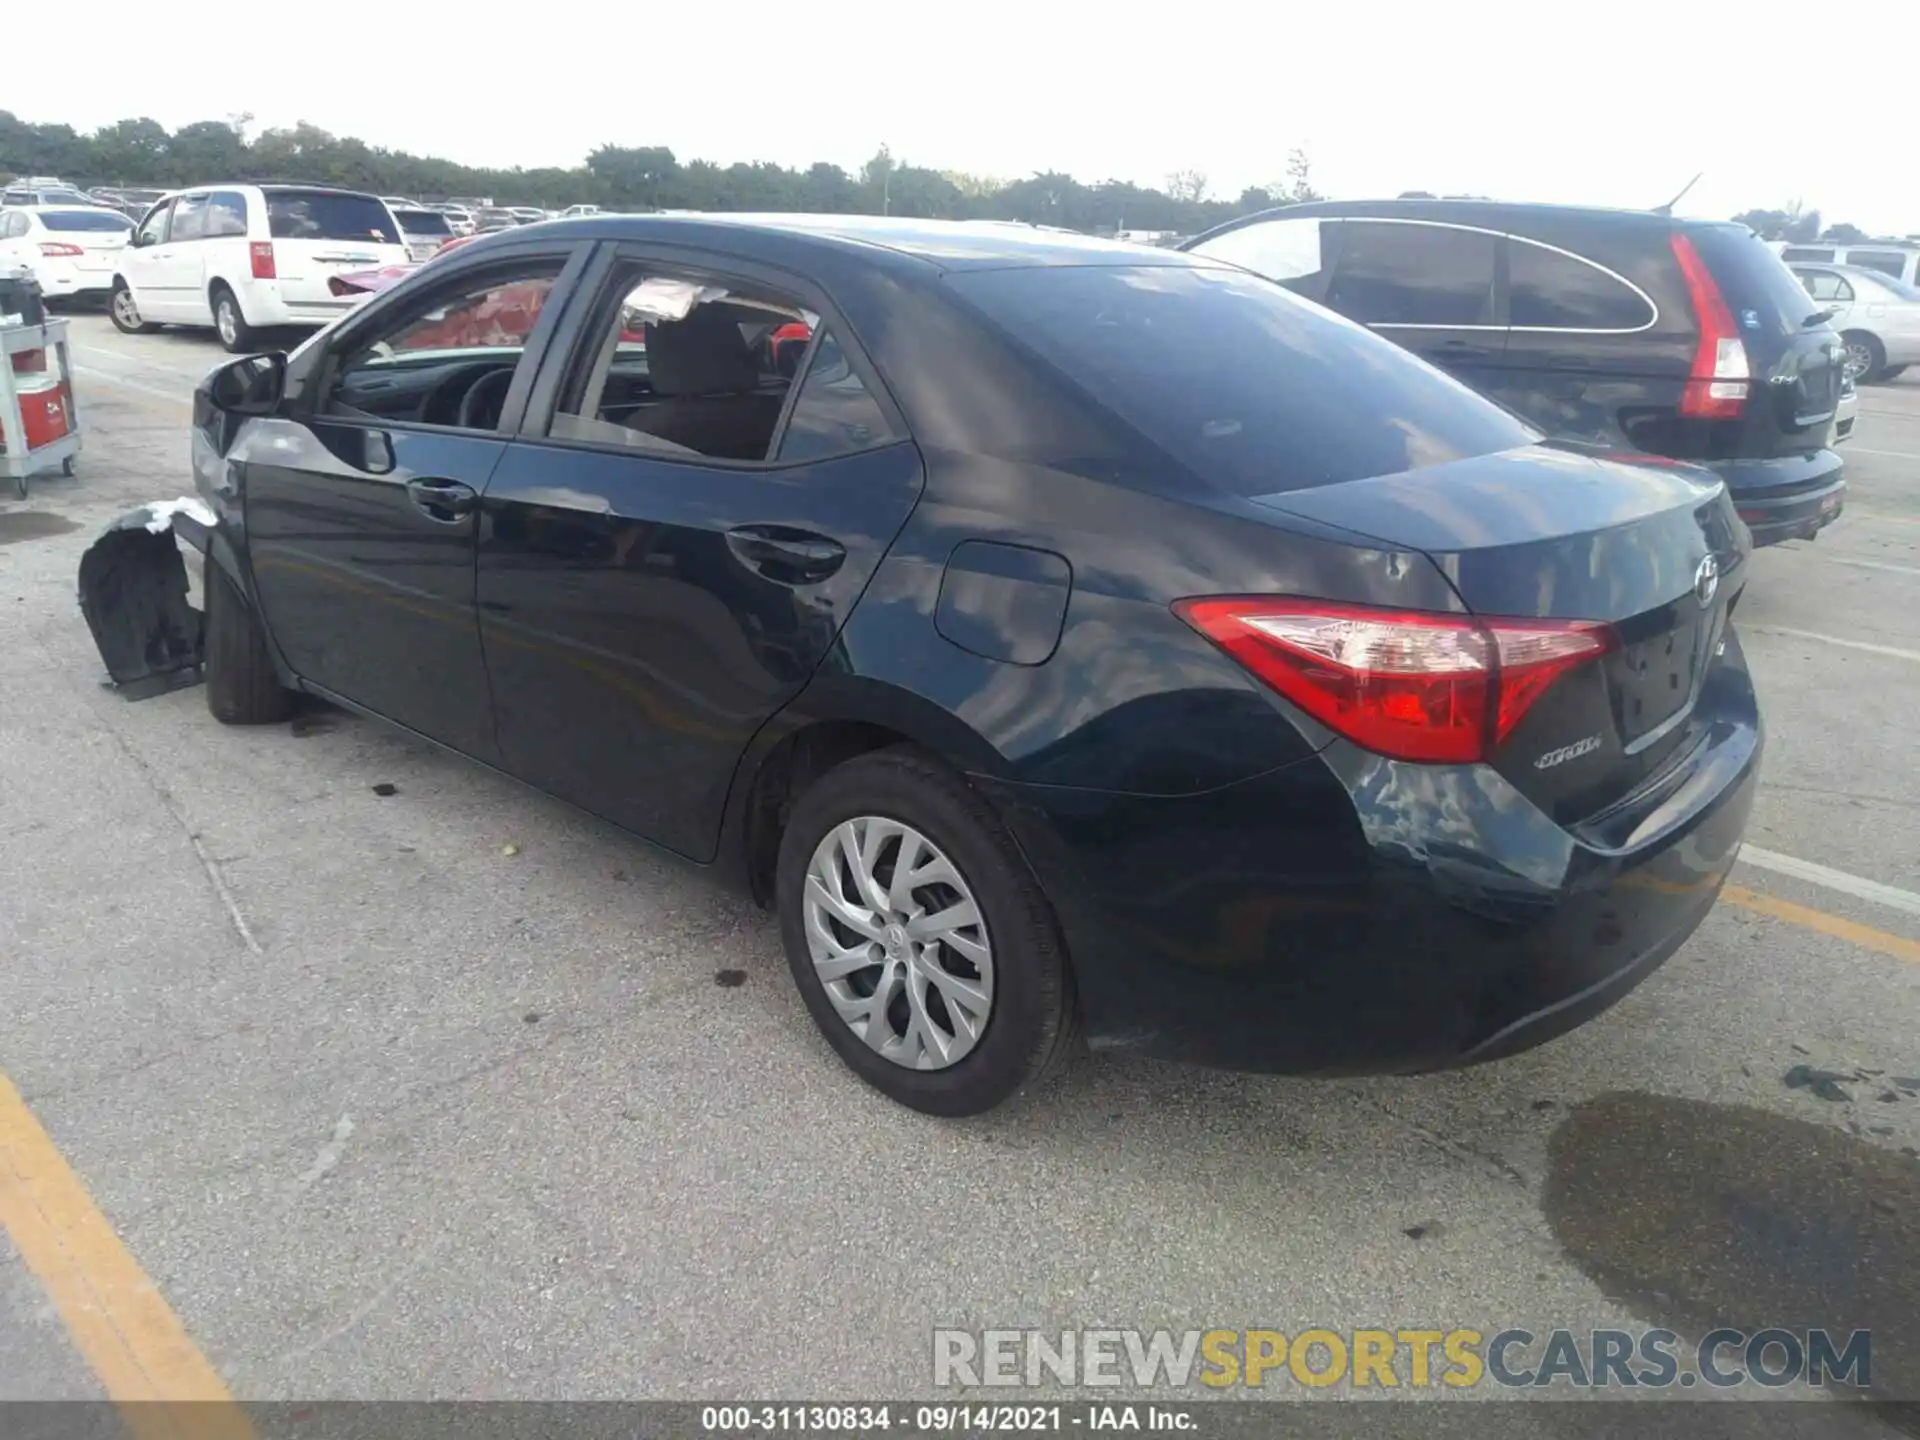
551;267;889;461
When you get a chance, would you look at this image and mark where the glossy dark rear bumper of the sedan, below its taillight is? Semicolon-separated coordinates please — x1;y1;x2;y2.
987;666;1763;1075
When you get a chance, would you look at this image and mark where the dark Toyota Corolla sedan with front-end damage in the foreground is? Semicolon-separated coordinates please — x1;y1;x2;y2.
194;217;1761;1114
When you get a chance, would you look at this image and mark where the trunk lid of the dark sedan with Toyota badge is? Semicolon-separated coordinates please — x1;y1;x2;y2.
1260;444;1747;824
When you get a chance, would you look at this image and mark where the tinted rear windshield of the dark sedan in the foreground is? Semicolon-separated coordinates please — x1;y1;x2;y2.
948;267;1528;495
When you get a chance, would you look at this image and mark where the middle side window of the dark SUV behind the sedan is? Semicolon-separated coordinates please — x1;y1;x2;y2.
1327;221;1496;324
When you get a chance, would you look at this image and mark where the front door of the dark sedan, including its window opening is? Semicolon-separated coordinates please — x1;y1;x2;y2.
240;244;584;762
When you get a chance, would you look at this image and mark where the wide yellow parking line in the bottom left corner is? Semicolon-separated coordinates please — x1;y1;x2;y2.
0;1075;253;1440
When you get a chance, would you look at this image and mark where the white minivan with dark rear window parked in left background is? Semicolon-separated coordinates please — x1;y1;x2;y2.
109;184;407;353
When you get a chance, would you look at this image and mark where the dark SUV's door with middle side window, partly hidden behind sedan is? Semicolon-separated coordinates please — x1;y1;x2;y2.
1327;217;1507;388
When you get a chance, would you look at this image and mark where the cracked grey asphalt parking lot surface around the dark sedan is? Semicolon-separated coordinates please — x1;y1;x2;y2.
0;315;1920;1436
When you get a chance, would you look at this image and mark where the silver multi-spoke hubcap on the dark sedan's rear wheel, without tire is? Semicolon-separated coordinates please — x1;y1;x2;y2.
801;816;993;1069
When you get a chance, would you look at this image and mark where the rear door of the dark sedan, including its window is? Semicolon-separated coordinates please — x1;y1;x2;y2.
478;250;922;860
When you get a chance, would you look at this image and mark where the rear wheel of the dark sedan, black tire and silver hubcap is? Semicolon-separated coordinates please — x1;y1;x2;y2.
776;747;1073;1116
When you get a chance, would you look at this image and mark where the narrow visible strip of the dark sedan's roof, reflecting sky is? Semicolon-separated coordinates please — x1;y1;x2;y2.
468;211;1182;271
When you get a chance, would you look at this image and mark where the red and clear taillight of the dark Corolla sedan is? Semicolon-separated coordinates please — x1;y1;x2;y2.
1173;595;1615;764
